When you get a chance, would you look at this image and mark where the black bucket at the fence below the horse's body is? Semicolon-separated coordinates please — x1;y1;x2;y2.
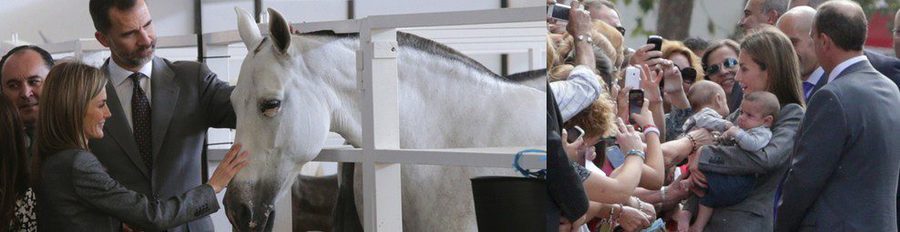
472;176;550;232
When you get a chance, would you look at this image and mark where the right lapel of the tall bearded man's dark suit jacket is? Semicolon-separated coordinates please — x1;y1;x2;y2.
150;57;179;166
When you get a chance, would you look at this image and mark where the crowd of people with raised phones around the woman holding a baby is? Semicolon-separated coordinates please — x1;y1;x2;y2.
547;0;900;231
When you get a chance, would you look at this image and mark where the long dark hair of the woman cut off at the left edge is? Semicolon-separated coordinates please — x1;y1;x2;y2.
0;97;28;227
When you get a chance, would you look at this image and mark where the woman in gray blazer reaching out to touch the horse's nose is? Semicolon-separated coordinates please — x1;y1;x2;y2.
33;62;247;231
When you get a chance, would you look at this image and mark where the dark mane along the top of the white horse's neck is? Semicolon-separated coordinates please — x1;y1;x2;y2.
301;30;547;84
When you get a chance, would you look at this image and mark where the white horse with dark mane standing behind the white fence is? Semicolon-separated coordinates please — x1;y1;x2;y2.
225;9;547;231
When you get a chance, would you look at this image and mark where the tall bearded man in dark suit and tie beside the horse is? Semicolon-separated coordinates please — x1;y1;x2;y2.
90;0;235;231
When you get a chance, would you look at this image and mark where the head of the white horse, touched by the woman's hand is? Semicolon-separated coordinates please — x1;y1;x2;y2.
224;8;330;231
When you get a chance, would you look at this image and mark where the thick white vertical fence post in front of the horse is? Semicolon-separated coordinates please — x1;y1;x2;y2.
357;19;403;231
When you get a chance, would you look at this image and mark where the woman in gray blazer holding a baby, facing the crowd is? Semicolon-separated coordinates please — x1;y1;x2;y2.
666;27;805;231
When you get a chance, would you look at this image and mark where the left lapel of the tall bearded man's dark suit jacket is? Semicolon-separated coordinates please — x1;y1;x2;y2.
101;59;150;178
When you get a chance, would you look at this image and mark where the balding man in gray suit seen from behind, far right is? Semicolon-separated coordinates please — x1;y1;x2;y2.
775;1;900;231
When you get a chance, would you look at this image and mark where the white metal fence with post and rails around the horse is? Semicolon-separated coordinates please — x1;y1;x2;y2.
41;7;546;231
